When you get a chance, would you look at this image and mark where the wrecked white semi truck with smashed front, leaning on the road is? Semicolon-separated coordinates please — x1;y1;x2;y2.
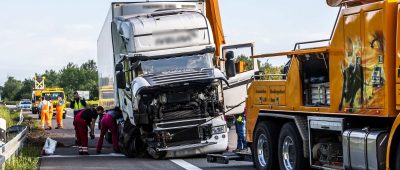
98;1;228;158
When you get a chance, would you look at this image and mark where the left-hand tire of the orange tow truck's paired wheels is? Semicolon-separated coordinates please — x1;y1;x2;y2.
252;121;279;170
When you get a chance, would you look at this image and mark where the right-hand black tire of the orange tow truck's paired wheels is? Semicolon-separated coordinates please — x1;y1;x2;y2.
278;122;307;170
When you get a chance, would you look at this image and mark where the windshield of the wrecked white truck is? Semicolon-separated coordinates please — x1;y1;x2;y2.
136;54;214;76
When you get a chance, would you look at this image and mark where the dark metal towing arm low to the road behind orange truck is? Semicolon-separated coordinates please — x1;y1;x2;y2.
207;152;253;164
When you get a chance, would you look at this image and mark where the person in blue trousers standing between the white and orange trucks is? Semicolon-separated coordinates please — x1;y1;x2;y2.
235;114;247;152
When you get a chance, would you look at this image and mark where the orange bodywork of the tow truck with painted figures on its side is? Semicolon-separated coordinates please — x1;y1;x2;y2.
246;0;400;169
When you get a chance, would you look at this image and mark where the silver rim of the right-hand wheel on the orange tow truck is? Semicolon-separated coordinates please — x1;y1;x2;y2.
282;136;296;170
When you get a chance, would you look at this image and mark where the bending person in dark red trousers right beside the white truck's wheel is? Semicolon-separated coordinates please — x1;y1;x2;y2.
97;106;122;154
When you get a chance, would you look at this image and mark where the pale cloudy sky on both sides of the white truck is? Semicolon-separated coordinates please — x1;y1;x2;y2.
0;0;338;85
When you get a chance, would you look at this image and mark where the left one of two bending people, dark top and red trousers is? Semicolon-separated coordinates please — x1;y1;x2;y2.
74;109;97;155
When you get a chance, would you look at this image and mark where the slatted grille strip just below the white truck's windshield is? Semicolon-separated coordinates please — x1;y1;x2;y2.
151;71;211;85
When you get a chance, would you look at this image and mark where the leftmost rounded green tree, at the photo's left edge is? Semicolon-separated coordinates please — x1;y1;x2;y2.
2;76;22;101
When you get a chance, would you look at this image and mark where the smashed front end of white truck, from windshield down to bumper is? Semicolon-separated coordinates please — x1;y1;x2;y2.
115;53;228;158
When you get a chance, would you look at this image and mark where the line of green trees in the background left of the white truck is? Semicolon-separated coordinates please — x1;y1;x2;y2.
0;60;99;101
